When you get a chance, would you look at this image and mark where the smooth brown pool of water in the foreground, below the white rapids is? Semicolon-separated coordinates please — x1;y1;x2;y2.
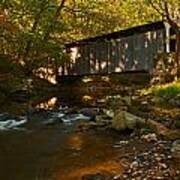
0;124;121;180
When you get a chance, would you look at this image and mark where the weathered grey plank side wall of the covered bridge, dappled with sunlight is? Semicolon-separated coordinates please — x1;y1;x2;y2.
60;23;165;75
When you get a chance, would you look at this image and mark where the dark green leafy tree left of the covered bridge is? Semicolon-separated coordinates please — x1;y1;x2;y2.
0;0;66;76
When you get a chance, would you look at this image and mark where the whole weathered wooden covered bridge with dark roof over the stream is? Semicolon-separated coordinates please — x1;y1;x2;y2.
56;21;174;80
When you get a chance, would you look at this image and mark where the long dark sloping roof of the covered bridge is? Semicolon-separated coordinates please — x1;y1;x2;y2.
65;21;165;48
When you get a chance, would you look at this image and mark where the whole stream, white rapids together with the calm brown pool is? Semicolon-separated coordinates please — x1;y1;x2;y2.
0;90;122;180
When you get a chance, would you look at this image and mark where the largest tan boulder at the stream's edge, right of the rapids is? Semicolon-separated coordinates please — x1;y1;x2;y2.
112;110;145;130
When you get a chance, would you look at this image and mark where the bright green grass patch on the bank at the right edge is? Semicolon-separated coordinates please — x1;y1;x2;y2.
142;79;180;99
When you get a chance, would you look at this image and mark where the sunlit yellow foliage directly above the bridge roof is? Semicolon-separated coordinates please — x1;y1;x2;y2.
63;0;160;41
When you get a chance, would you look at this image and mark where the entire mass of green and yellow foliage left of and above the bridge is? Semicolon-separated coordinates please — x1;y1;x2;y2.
0;0;179;82
